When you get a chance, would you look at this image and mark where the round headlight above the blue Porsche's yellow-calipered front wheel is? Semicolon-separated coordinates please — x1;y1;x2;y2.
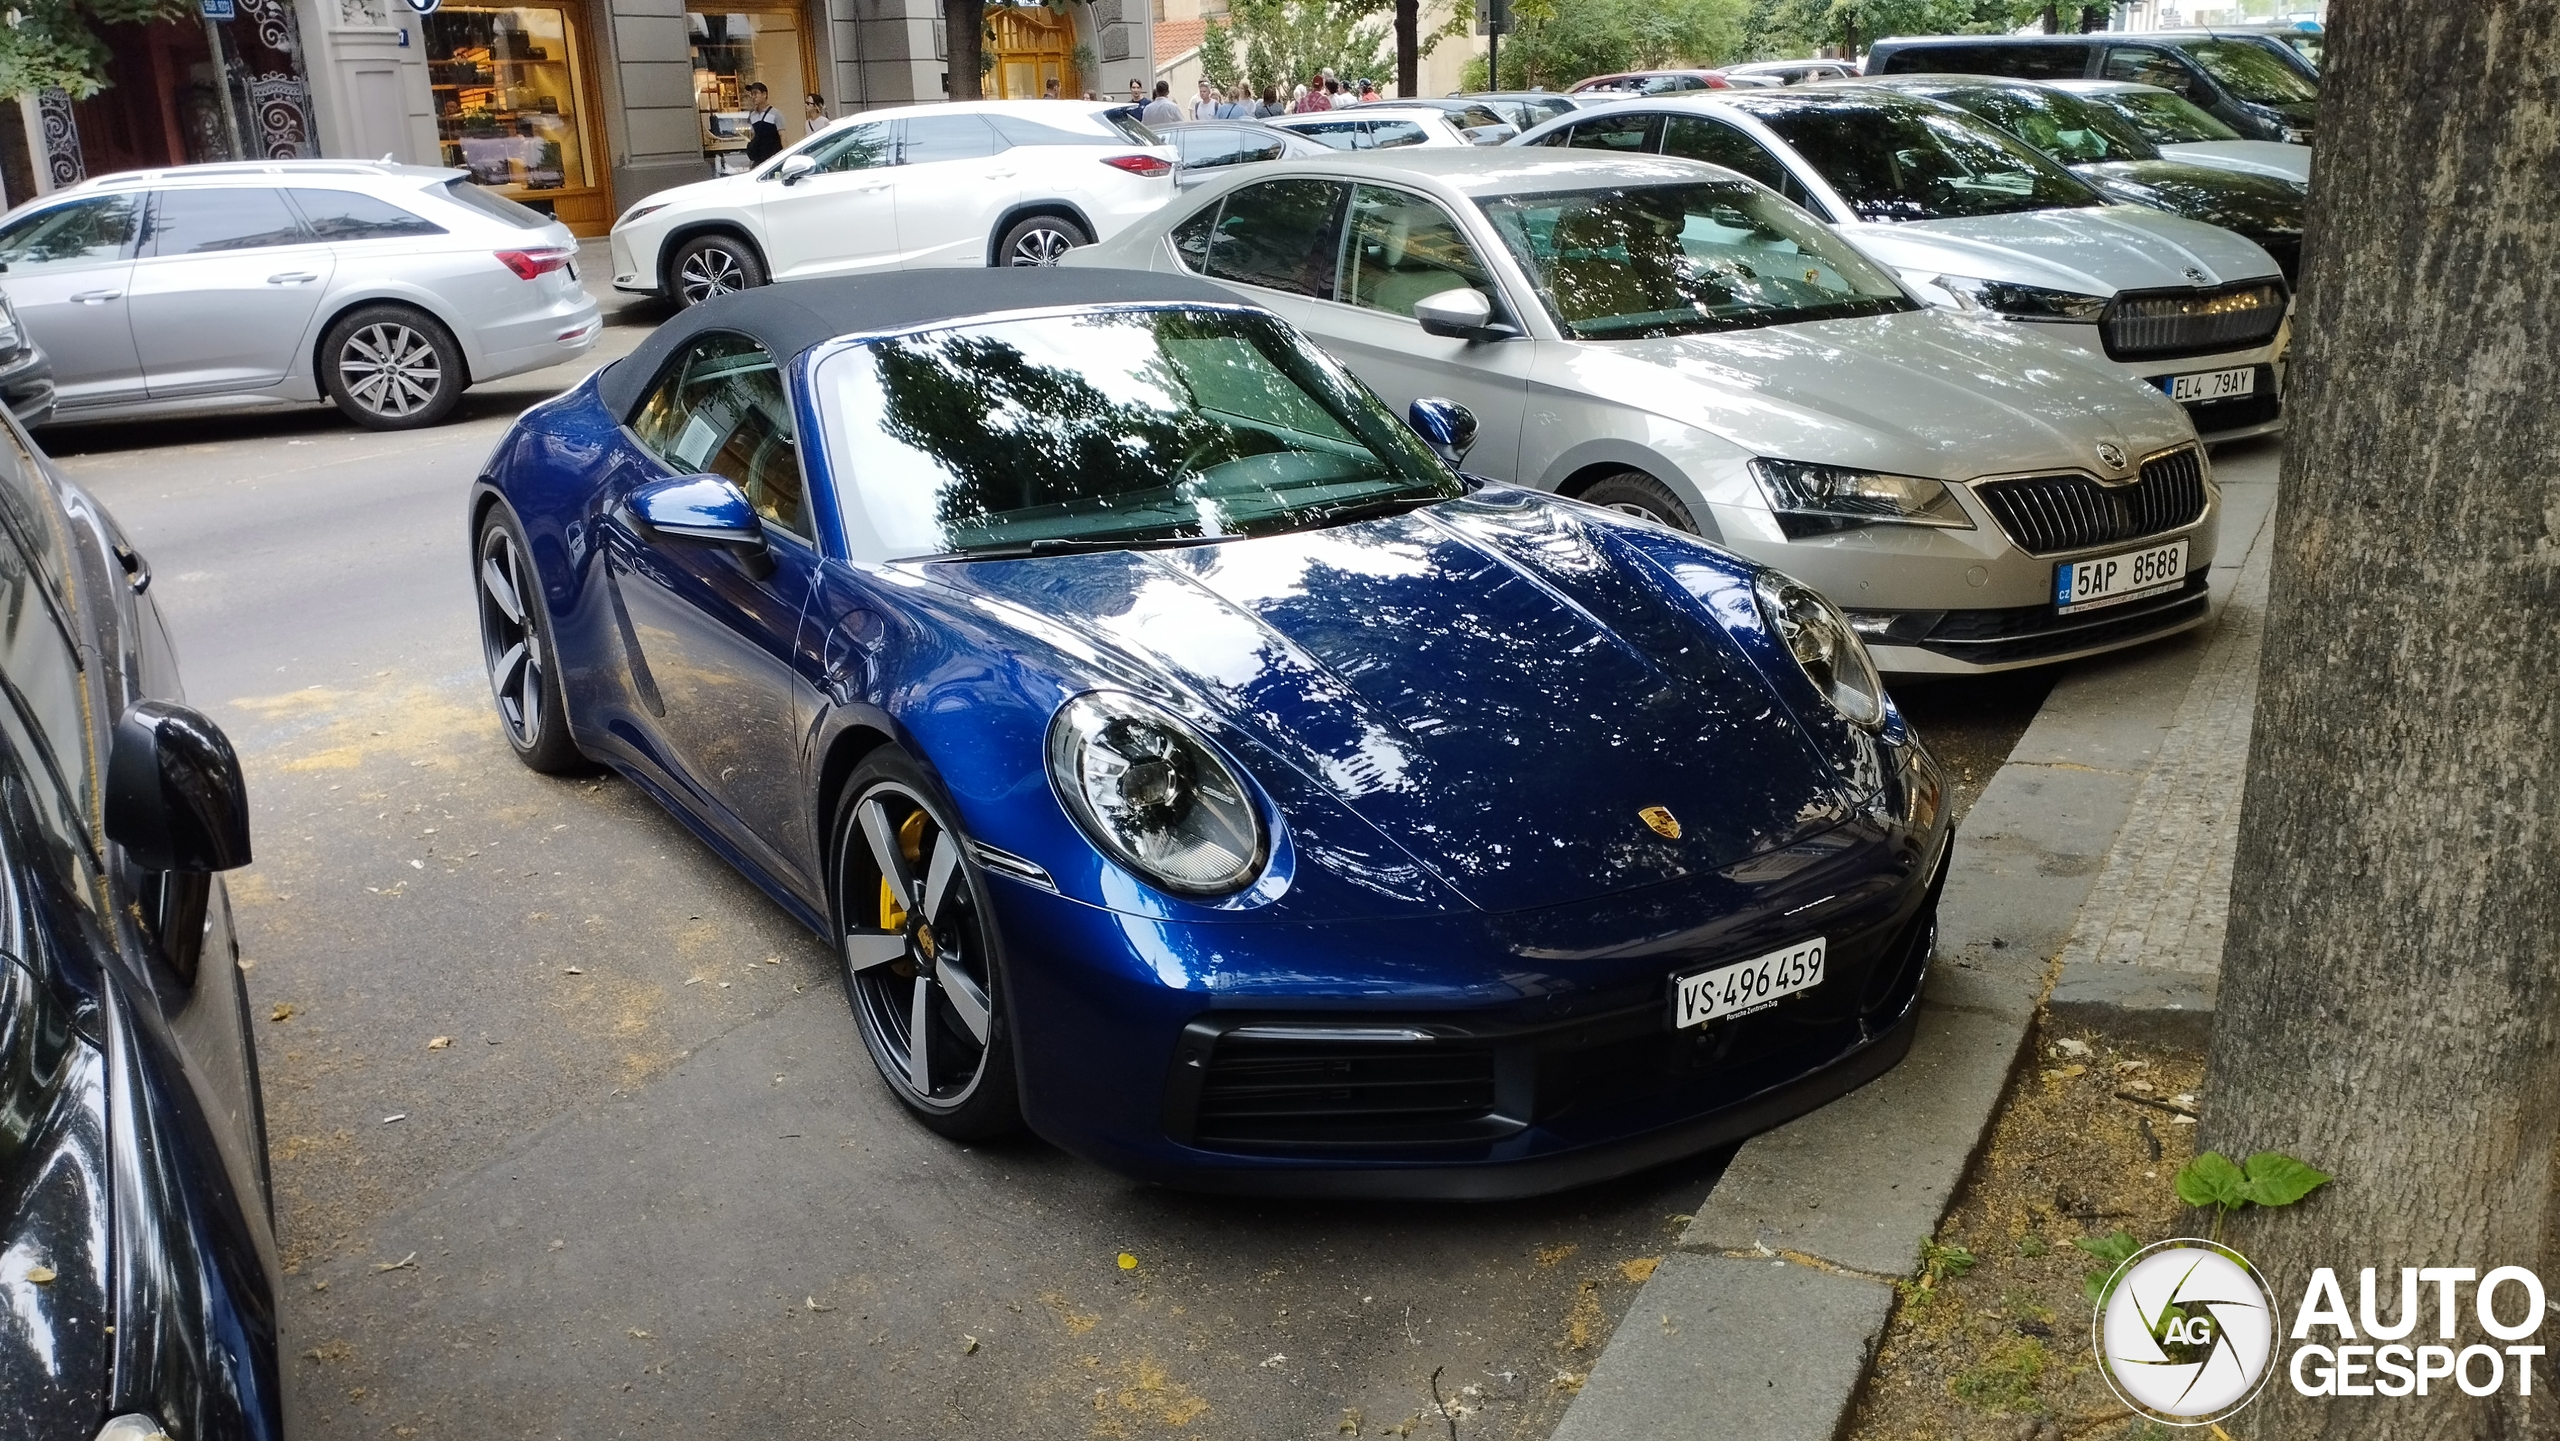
1050;691;1270;896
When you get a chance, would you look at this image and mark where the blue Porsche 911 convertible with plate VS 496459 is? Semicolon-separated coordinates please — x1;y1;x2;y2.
471;269;1951;1198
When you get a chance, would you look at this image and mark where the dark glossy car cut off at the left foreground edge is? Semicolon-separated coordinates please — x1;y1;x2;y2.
0;412;284;1441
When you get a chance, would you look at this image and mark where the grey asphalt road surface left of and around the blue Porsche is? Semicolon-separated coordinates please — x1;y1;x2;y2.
44;278;2043;1438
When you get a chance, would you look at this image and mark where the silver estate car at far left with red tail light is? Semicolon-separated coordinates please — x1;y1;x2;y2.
0;161;604;430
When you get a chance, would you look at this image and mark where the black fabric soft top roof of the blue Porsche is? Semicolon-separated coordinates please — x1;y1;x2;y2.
596;266;1236;415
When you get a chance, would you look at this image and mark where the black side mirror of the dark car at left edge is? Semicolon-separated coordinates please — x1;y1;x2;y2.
108;701;248;873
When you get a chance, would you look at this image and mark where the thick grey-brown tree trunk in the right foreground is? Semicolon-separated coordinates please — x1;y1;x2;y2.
2204;0;2560;1441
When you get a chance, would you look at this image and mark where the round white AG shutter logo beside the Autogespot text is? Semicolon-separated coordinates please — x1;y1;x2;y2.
2092;1239;2276;1426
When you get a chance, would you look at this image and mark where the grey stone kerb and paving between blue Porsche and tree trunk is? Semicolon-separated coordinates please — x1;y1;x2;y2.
1554;445;2276;1441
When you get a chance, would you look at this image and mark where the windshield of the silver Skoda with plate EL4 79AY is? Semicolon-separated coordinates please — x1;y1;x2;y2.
1746;95;2102;220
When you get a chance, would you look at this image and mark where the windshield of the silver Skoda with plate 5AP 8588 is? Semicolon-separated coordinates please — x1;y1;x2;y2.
1477;179;1915;340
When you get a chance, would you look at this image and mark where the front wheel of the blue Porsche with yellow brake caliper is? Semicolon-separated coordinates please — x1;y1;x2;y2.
829;745;1021;1142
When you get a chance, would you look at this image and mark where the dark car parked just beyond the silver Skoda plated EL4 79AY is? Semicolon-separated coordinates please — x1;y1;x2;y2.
1859;74;2312;284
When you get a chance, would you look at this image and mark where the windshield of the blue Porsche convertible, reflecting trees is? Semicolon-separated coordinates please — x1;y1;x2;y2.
817;307;1464;558
